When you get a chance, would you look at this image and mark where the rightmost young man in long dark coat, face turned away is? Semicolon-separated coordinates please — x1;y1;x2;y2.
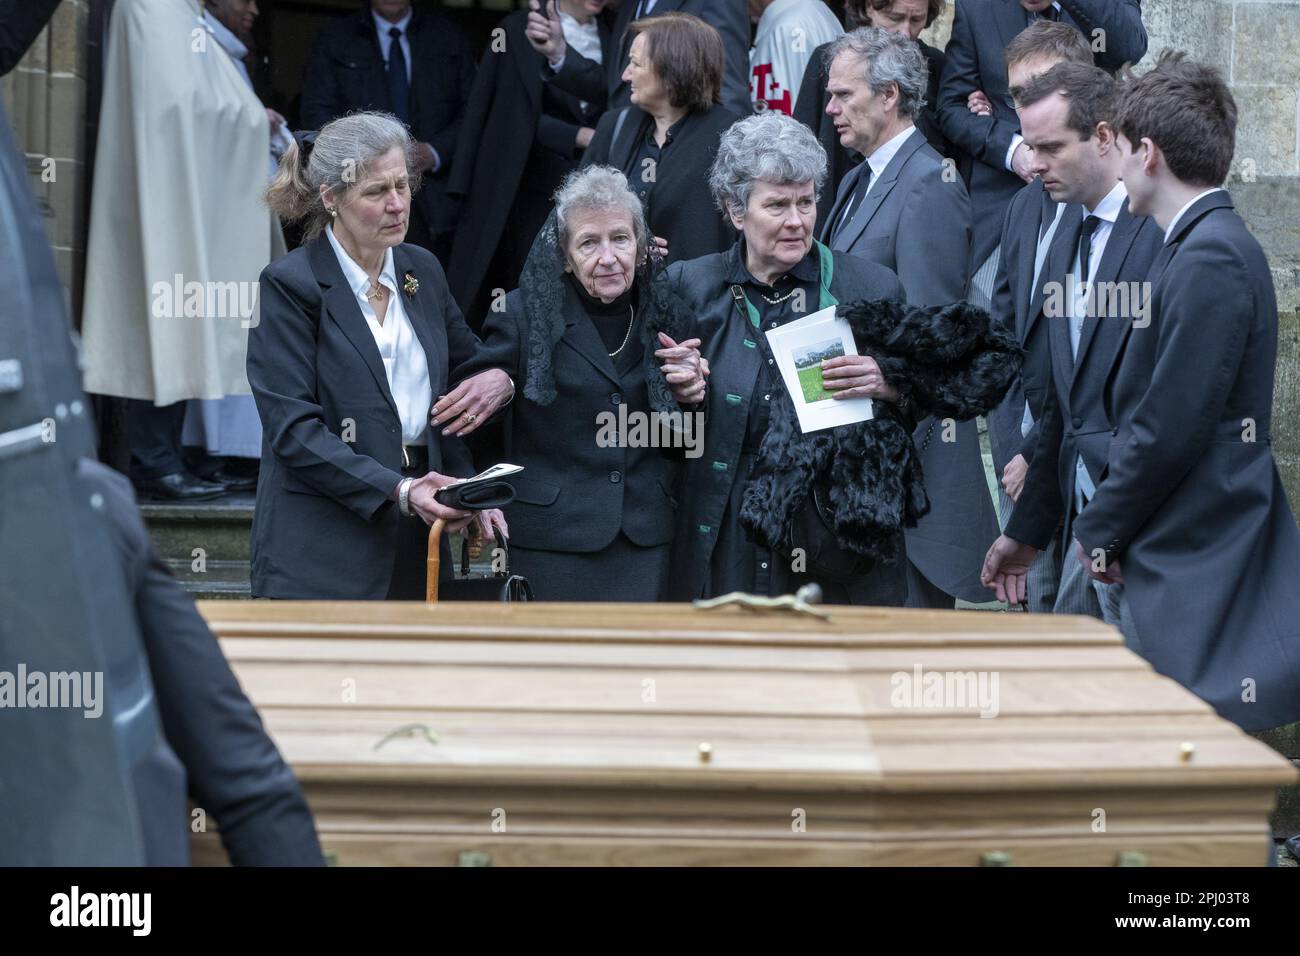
985;53;1300;730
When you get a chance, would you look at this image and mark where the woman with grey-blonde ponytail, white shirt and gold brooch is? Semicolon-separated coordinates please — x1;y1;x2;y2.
248;113;515;600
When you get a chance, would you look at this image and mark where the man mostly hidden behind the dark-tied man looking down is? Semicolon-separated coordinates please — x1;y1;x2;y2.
971;20;1101;617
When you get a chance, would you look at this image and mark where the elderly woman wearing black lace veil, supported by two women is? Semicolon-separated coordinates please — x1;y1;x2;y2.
452;165;706;601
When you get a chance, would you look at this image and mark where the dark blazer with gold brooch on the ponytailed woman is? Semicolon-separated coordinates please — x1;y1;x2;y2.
248;235;480;600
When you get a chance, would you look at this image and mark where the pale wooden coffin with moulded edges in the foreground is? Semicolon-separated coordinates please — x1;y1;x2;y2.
195;601;1296;866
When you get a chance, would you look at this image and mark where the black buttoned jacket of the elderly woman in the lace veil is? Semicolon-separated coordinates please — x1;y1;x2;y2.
462;281;676;554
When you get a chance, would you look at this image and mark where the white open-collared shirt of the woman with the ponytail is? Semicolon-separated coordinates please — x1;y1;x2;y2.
325;226;433;445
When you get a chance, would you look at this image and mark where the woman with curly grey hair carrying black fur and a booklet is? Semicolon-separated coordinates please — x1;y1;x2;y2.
662;112;1019;606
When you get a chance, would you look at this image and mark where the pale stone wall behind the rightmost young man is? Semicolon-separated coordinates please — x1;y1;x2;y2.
923;0;1300;510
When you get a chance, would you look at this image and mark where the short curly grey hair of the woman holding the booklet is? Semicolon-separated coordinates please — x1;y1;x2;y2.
709;111;826;216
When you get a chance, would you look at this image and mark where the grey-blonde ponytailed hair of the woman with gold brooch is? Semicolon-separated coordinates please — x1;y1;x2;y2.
267;113;420;239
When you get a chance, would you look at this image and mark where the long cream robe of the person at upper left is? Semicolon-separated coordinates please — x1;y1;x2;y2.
82;0;278;405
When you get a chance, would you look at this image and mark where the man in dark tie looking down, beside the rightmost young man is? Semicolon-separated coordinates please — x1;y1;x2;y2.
987;64;1164;626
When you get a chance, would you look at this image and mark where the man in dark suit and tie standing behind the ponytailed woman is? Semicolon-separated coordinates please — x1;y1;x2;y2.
302;0;475;263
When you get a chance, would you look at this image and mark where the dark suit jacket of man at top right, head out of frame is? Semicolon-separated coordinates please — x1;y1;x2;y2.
939;0;1147;271
